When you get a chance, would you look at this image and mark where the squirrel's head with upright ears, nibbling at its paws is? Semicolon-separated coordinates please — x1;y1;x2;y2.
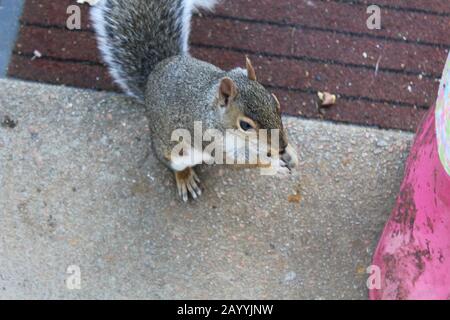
217;57;298;169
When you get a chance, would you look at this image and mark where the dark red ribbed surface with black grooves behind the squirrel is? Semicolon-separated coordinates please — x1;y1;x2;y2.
9;0;450;130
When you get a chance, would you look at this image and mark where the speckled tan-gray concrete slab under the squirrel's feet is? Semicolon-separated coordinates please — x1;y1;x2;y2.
0;80;412;299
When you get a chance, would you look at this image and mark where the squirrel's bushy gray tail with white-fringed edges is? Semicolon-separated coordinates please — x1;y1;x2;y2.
91;0;217;99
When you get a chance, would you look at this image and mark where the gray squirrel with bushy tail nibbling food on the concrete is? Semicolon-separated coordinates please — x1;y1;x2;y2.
91;0;298;201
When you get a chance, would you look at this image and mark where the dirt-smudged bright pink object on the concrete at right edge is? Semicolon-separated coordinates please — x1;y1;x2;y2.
369;108;450;299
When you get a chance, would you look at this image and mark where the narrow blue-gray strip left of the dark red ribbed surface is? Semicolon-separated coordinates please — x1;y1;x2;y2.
0;0;23;78
